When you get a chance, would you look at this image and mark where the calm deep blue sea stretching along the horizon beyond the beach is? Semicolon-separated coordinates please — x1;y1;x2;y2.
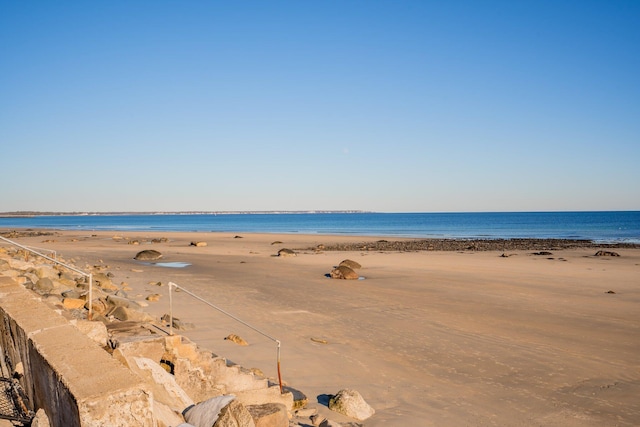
0;211;640;243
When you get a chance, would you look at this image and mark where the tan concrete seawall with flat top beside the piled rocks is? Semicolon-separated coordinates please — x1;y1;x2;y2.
0;277;155;427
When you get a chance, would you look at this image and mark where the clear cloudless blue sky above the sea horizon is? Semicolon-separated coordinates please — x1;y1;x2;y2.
0;0;640;212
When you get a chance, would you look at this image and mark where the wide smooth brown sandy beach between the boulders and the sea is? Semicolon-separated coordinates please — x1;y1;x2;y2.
6;232;640;427
